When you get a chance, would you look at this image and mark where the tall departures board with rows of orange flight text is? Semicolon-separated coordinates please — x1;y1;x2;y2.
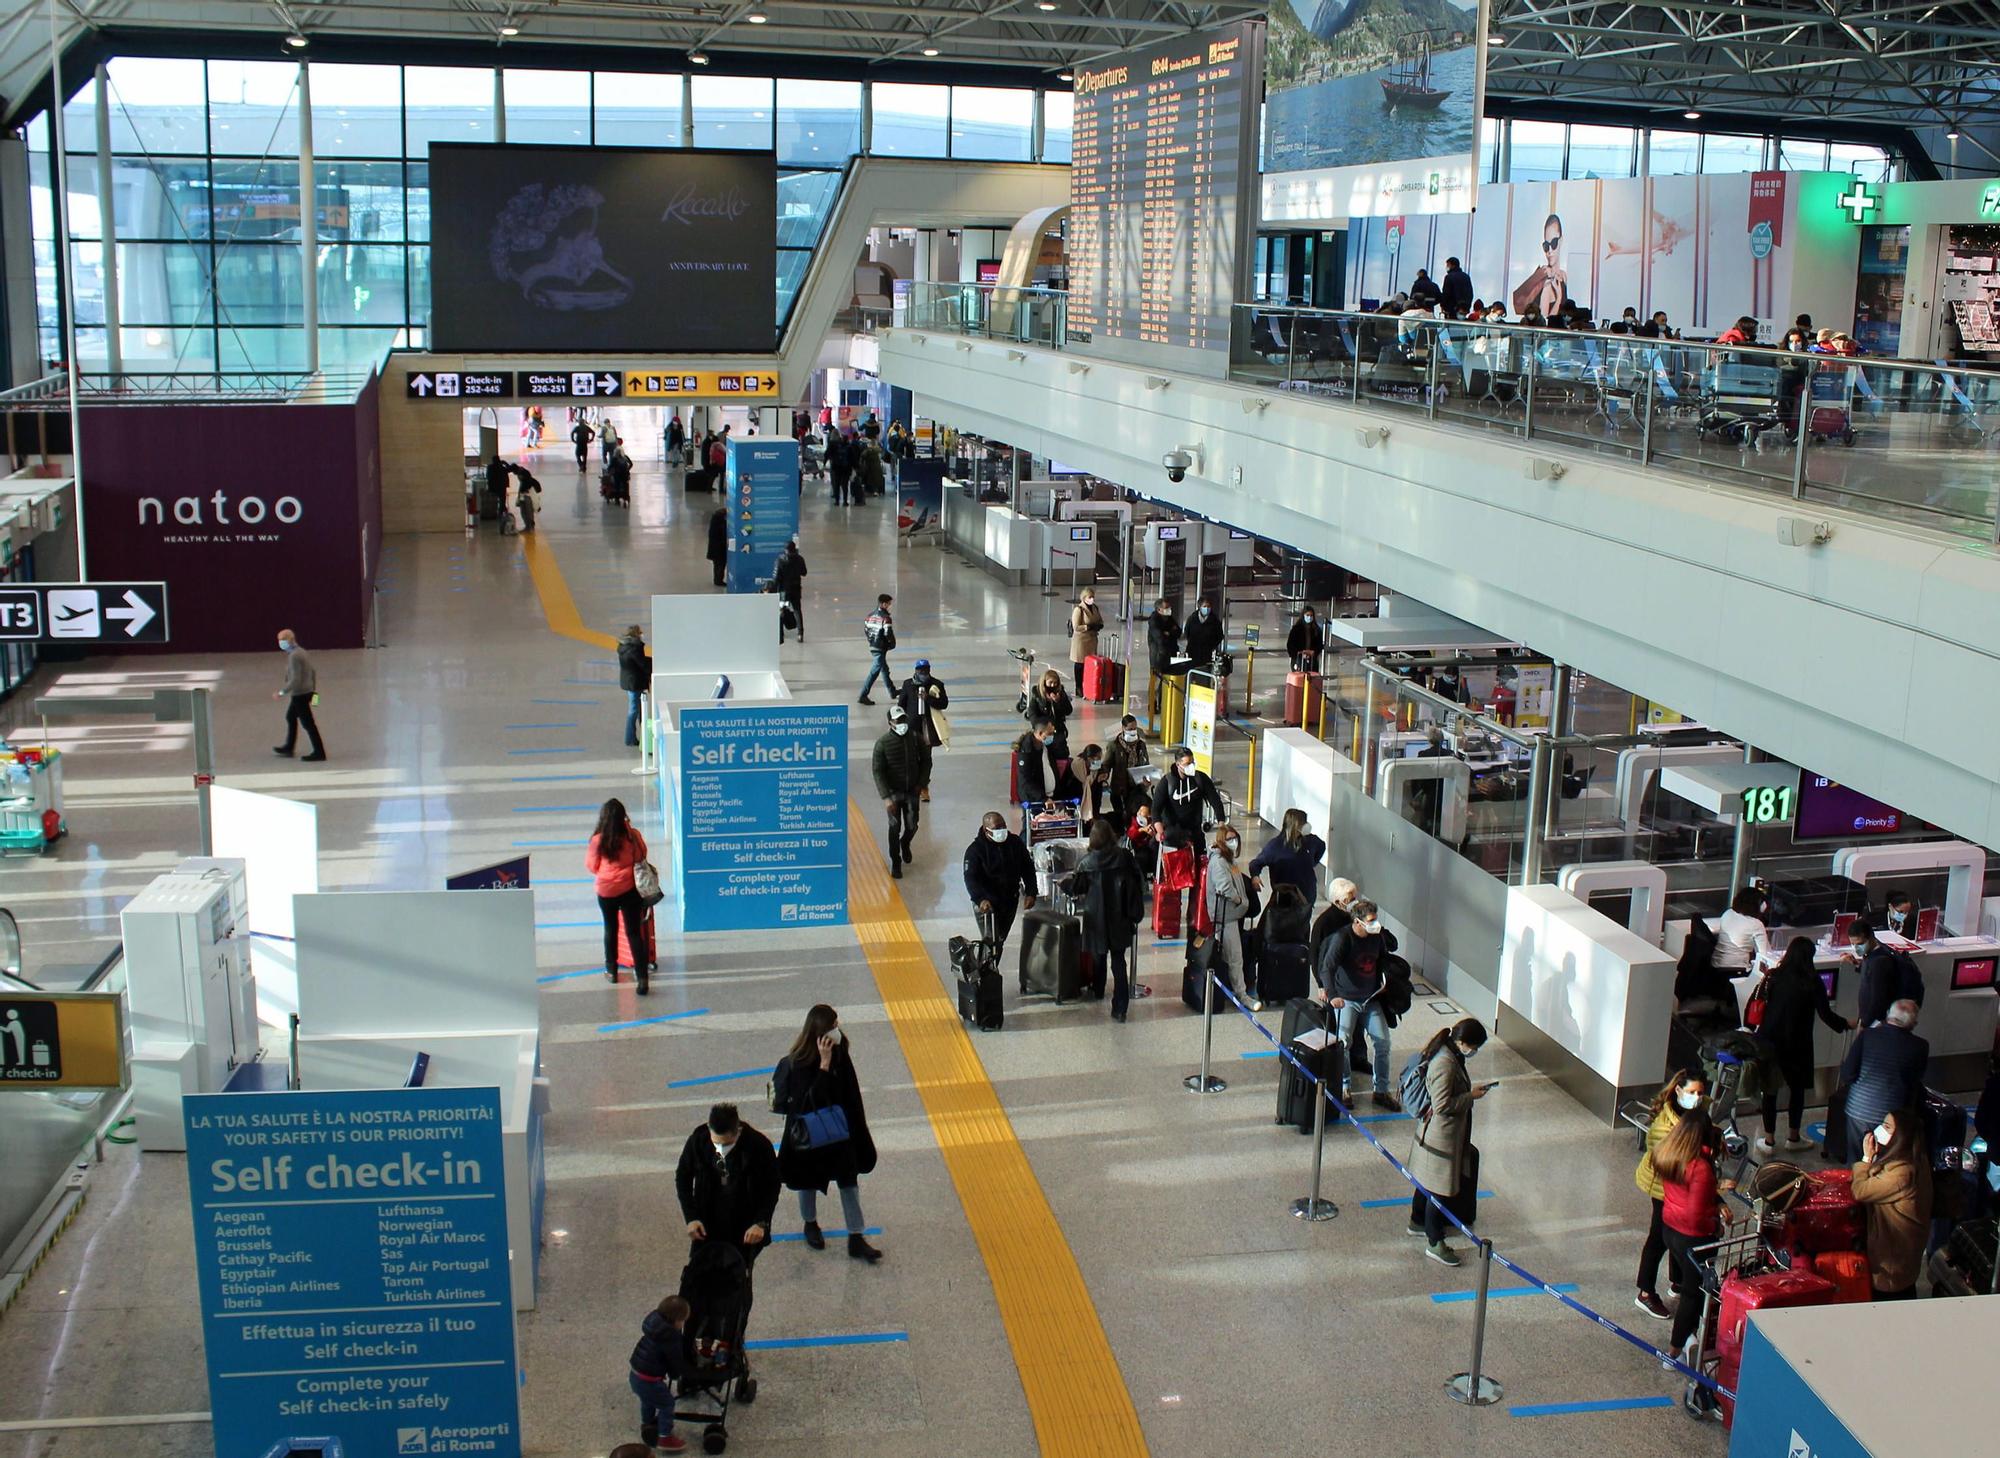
1068;20;1264;368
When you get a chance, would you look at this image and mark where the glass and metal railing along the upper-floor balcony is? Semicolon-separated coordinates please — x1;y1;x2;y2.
904;284;2000;542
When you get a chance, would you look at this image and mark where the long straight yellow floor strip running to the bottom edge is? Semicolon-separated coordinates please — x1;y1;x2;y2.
848;802;1146;1458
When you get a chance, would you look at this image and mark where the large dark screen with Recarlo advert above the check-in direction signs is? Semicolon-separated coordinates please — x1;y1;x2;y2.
430;144;778;354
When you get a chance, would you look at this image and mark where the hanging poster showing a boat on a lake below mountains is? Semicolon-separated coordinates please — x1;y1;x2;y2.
1264;0;1484;220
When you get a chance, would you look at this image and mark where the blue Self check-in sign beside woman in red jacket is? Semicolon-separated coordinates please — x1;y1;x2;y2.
674;704;848;932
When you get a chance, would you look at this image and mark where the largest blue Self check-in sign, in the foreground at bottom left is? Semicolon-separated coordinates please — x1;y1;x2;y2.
182;1088;520;1458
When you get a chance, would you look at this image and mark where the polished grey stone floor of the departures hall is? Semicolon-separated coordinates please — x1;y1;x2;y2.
0;452;1726;1458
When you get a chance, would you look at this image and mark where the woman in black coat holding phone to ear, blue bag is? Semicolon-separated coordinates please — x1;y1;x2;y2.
770;1002;882;1264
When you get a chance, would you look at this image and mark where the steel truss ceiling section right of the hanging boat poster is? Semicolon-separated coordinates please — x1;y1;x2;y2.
1486;0;2000;128
